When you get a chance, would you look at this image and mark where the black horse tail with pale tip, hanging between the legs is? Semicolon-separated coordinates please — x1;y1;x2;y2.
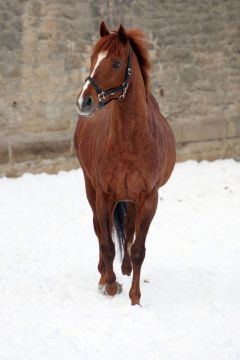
113;202;127;259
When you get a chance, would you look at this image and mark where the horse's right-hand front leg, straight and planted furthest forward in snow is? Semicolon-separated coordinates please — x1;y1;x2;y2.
129;190;158;305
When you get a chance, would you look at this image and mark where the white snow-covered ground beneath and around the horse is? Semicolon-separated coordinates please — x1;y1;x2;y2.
0;160;240;360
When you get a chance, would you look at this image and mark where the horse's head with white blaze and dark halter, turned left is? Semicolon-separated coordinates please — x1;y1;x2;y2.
77;22;131;116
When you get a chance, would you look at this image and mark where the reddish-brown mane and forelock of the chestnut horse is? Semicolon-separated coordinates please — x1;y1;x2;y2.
92;29;151;93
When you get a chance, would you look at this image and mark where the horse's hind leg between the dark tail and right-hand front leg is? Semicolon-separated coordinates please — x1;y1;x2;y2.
122;202;136;276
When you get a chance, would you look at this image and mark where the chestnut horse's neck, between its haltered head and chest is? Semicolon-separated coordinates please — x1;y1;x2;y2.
110;69;148;146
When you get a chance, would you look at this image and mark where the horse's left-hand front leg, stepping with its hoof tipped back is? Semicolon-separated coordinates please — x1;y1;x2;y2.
96;192;121;296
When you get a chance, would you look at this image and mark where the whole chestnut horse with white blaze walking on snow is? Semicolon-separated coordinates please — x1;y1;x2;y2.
74;22;176;305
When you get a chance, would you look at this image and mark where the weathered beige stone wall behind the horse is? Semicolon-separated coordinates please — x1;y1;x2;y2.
0;0;240;176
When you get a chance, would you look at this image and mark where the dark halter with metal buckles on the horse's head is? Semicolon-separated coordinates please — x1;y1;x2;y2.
85;48;132;109
